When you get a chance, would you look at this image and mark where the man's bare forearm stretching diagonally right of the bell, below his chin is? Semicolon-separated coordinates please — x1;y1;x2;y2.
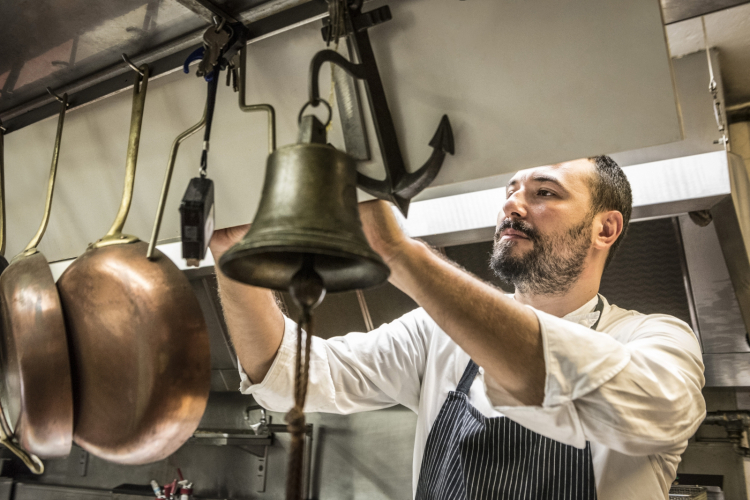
389;240;546;405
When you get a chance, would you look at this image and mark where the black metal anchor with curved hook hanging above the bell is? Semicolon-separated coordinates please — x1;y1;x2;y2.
309;2;454;216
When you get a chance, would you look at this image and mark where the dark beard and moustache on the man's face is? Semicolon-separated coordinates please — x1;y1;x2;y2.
490;214;594;295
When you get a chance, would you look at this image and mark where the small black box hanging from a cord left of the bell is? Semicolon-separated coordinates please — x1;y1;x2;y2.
180;177;215;267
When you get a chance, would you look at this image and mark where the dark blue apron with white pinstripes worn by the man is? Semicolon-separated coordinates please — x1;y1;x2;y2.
415;297;604;500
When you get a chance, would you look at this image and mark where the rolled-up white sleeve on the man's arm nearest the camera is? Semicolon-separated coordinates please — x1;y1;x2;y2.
488;311;705;455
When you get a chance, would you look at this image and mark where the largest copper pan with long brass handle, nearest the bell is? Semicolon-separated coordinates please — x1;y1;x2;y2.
57;65;210;464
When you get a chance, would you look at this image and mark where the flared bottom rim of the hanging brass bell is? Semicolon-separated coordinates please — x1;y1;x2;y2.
218;245;391;293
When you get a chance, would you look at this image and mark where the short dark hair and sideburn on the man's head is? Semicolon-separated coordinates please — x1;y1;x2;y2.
589;155;633;269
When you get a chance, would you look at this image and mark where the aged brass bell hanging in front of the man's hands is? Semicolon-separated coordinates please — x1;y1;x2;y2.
219;115;390;292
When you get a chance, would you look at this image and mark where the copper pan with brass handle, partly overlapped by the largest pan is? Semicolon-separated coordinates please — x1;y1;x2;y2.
0;94;73;464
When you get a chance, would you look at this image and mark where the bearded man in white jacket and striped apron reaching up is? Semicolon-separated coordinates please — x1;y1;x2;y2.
211;156;705;500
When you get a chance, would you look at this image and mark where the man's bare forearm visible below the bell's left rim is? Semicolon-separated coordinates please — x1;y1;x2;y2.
216;268;284;383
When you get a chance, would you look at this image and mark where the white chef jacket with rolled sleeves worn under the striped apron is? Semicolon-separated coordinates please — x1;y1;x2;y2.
240;297;706;500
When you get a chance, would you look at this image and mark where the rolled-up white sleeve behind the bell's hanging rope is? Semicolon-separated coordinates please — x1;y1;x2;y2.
240;309;434;414
